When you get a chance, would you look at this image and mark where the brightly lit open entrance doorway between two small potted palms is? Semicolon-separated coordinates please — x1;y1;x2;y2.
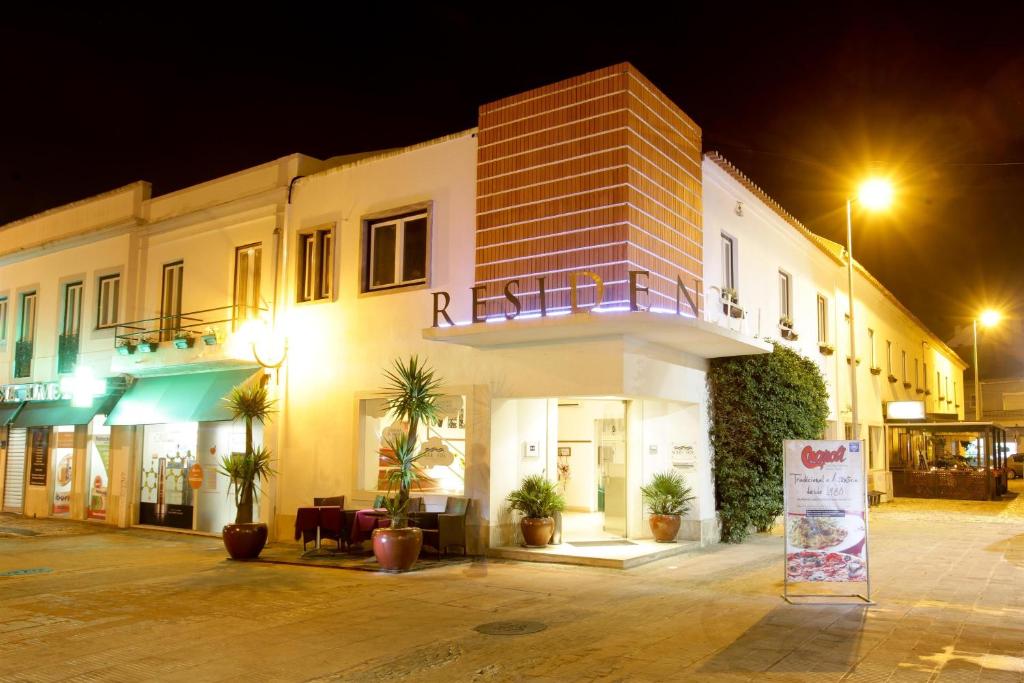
556;398;627;543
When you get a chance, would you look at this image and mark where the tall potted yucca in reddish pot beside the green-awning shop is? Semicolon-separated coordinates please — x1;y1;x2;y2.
220;383;273;560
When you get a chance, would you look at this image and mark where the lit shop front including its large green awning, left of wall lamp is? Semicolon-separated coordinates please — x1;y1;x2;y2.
108;368;261;533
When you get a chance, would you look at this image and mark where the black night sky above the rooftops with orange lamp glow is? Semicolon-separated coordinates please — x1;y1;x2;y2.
0;3;1024;355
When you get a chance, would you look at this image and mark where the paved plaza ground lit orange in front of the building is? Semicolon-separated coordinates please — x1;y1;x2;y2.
0;483;1024;683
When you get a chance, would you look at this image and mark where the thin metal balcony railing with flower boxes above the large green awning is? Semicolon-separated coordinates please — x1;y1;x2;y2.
114;305;266;353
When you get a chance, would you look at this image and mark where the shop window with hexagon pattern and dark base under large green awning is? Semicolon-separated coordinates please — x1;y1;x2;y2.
138;422;199;529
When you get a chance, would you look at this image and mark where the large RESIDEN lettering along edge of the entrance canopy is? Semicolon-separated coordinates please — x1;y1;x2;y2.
432;270;698;328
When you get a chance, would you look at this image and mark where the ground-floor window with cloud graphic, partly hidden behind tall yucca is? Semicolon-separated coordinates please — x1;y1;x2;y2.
359;396;466;496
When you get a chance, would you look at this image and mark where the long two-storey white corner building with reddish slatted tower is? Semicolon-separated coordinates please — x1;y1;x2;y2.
0;65;964;552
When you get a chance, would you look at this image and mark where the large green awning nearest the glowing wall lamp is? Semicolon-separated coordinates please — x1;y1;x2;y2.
106;368;257;426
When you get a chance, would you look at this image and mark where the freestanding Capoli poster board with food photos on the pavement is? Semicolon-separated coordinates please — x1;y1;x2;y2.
783;439;867;583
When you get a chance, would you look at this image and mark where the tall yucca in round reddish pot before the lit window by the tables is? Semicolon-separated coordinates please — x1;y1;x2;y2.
373;355;441;570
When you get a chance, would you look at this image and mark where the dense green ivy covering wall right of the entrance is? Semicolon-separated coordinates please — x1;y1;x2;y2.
708;342;828;543
